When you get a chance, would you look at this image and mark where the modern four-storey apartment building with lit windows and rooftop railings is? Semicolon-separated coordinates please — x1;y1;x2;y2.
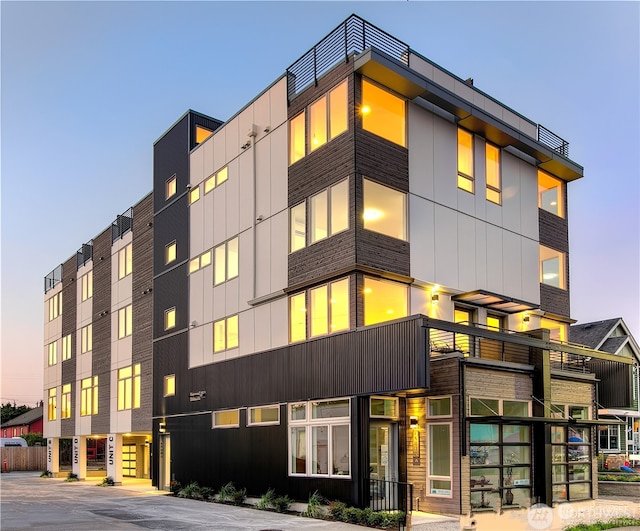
45;15;632;514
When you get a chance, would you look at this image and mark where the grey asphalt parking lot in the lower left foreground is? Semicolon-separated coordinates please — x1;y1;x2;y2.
0;472;364;531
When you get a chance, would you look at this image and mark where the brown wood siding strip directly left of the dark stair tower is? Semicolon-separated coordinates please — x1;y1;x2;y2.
131;194;153;431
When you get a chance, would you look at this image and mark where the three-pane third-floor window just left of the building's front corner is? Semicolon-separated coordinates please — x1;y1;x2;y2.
290;179;349;252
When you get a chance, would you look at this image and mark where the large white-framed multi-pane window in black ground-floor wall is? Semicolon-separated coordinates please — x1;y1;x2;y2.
289;398;351;479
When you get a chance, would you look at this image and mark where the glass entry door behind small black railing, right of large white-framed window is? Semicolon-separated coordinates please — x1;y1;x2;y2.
369;421;398;506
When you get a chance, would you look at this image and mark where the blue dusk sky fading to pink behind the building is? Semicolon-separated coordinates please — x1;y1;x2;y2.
0;1;640;405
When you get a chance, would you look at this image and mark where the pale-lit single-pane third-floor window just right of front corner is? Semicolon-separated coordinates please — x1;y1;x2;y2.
362;179;407;240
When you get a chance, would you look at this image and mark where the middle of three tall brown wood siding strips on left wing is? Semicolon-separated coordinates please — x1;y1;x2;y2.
90;227;111;434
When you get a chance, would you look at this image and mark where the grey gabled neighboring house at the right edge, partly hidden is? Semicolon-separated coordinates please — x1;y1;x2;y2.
569;318;640;461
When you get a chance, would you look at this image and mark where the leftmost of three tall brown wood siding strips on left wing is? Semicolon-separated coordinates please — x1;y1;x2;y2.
58;254;79;437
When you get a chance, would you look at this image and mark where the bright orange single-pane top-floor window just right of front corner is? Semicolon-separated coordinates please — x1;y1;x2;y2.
360;79;407;147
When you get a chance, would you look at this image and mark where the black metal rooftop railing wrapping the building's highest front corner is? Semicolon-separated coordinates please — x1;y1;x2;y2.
287;15;409;100
